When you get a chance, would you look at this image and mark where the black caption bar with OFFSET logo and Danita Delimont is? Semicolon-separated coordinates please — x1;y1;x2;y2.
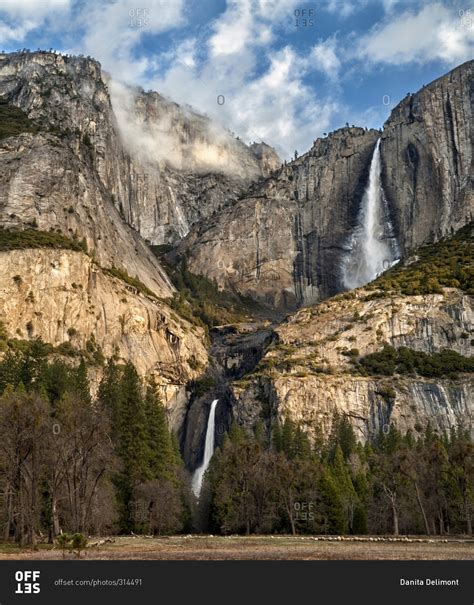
0;560;474;605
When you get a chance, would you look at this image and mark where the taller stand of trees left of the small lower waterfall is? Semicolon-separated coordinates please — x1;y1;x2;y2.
0;341;189;544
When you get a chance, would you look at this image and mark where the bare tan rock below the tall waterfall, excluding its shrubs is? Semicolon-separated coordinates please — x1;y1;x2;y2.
233;289;474;441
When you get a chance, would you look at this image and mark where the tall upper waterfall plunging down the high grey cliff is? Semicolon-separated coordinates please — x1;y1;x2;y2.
342;139;400;289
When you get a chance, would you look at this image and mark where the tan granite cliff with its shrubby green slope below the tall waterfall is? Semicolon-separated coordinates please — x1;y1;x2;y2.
232;223;474;440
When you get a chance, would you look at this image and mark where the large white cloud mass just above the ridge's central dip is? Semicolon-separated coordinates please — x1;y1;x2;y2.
152;46;337;157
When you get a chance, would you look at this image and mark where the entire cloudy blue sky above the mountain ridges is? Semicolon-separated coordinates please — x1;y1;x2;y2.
0;0;474;157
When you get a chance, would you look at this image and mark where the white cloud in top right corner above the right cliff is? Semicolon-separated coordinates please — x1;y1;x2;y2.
356;3;474;65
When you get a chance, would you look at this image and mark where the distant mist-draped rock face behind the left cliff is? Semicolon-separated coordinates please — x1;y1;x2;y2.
109;82;281;244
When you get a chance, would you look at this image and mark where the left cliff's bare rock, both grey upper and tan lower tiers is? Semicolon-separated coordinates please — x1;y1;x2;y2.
0;53;218;429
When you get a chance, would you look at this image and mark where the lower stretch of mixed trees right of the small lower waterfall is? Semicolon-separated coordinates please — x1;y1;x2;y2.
206;416;474;535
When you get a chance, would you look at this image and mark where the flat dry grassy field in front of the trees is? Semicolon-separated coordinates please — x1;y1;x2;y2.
0;536;474;561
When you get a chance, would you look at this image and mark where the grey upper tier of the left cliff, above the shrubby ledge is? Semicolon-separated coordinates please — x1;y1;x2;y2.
0;53;173;296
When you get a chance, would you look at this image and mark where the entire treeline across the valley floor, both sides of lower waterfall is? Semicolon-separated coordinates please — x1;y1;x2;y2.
0;340;474;544
